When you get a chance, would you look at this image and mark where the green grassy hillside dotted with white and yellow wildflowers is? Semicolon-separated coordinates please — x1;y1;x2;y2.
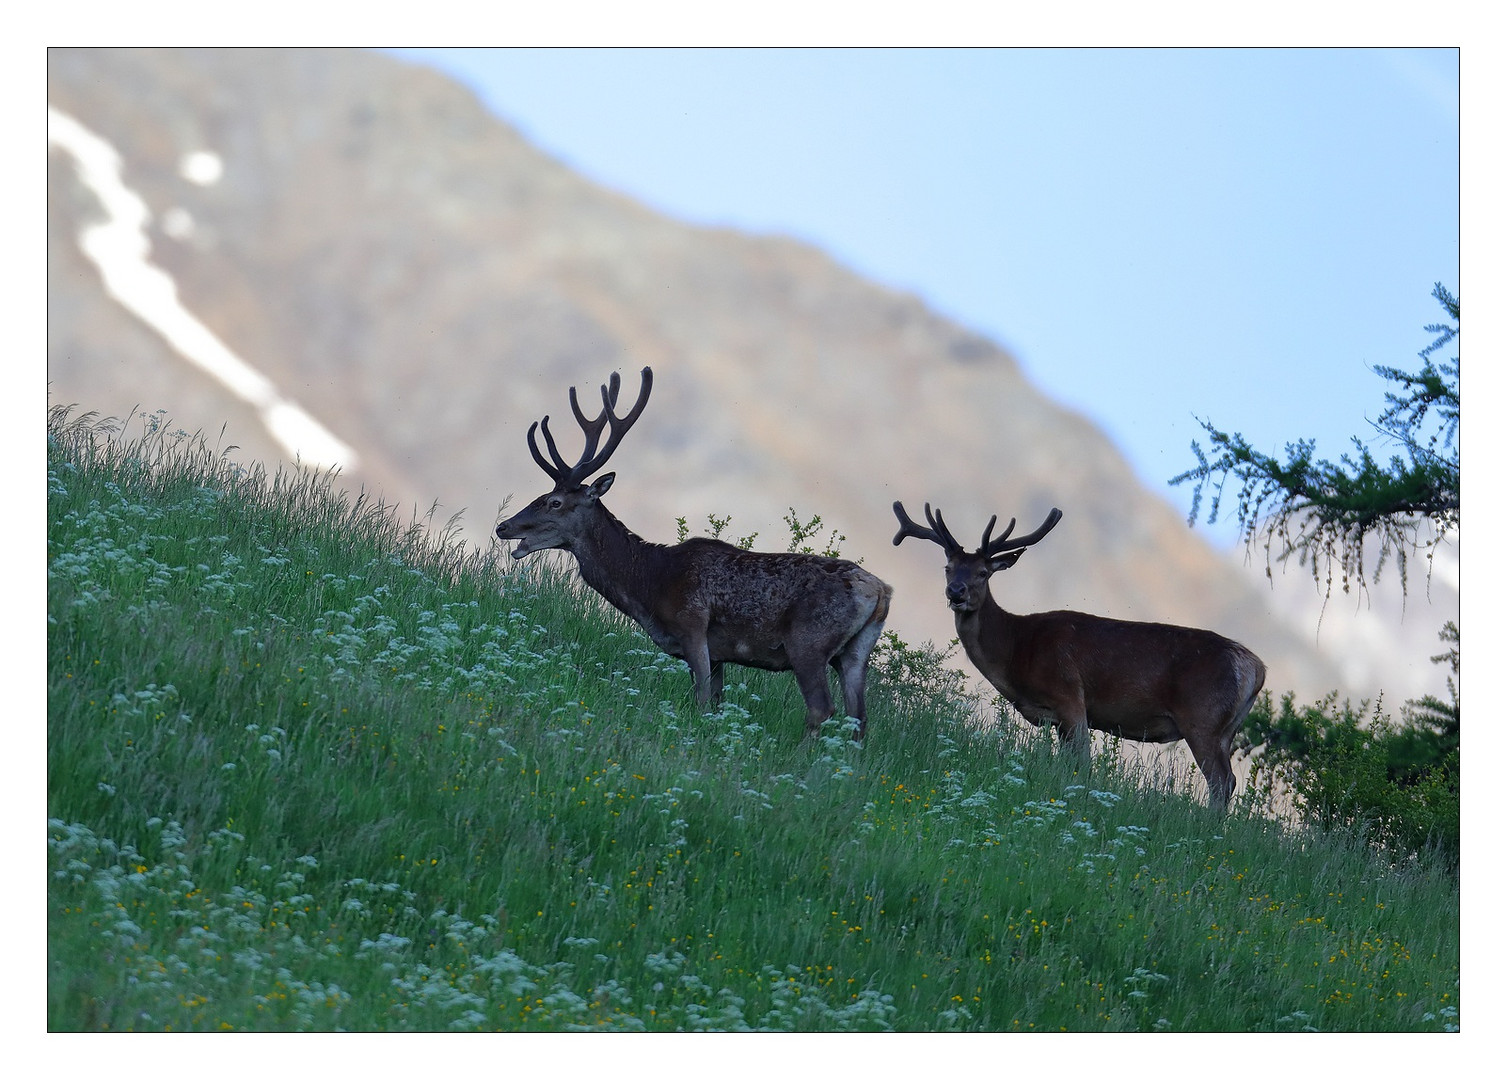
47;411;1460;1032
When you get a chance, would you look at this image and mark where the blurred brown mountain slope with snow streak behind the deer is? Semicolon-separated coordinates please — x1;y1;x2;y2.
48;50;1459;703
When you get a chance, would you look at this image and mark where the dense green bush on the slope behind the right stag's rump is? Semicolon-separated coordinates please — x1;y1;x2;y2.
1237;691;1460;869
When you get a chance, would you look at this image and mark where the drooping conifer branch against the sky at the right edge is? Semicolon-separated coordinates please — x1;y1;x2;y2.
1171;283;1460;590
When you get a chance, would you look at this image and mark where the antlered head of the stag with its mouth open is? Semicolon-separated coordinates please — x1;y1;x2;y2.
497;368;654;559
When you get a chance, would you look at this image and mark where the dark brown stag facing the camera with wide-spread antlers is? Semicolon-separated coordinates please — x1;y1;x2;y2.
895;502;1266;810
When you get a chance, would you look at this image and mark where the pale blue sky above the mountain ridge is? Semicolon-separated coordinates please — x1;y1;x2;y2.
396;48;1469;538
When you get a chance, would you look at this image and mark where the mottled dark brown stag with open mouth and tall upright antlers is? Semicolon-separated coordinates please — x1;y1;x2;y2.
497;368;891;738
